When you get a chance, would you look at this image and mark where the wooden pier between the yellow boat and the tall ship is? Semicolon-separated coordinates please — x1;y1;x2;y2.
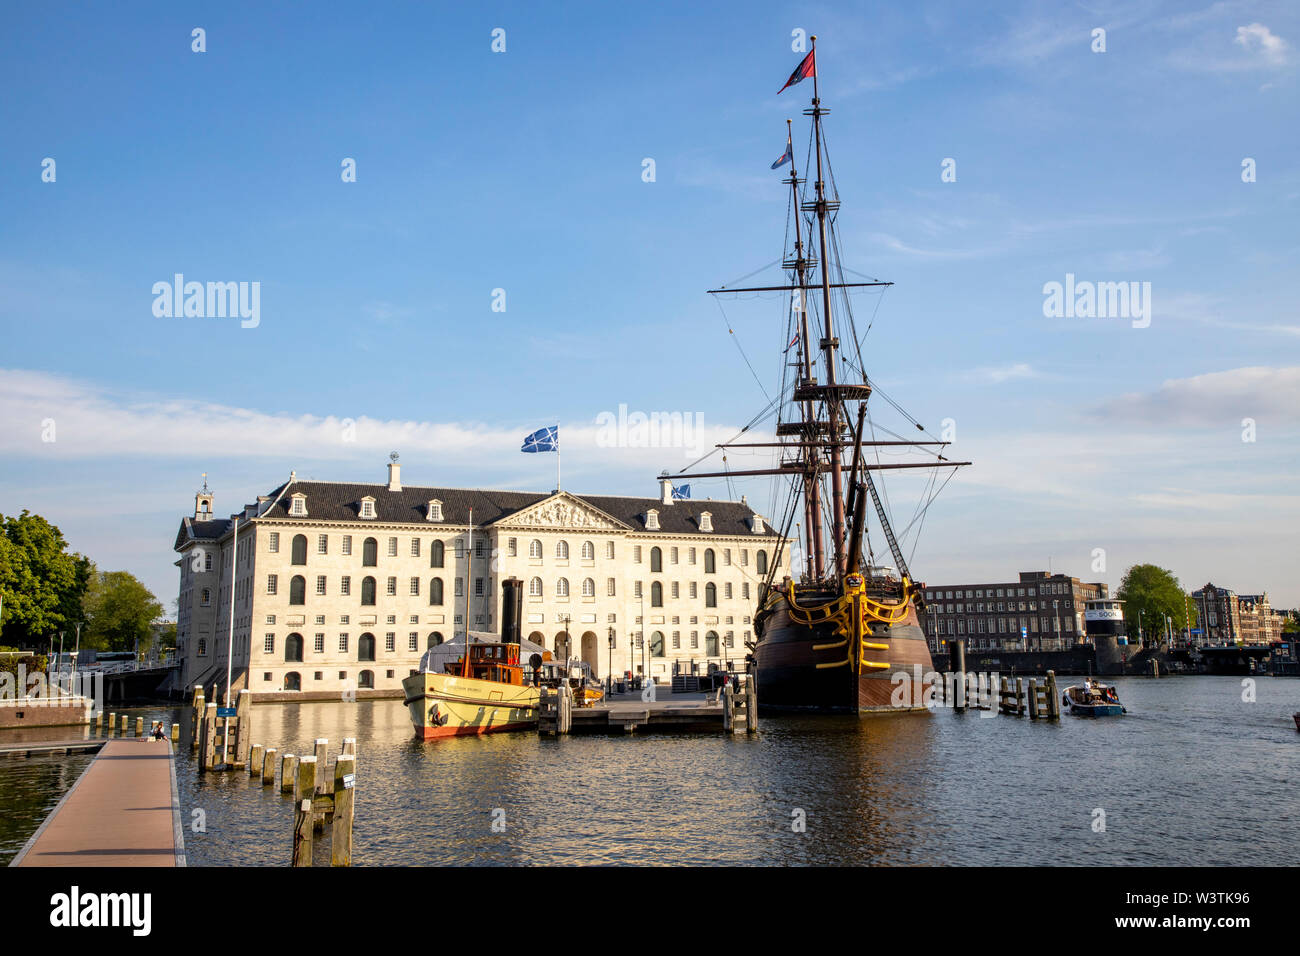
537;682;758;736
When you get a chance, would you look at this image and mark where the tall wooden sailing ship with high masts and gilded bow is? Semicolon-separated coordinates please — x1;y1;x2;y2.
684;36;970;714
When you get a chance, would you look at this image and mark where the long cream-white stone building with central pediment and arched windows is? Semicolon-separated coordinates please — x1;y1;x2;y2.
174;463;789;700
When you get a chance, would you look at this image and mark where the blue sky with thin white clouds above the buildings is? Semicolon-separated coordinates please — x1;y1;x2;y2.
0;1;1300;607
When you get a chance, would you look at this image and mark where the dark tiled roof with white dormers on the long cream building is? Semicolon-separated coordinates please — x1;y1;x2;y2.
245;481;775;537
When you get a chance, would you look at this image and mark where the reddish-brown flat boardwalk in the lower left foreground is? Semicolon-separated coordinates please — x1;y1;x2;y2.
9;737;185;866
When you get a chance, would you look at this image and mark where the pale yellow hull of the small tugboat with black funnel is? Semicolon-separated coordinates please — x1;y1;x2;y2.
402;672;540;740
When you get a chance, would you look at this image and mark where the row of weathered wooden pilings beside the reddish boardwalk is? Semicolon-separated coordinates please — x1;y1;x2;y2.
187;687;356;866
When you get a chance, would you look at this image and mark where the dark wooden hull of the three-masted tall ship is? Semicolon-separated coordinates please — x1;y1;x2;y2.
754;587;935;714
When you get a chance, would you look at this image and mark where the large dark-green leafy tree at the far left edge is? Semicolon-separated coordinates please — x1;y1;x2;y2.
0;511;92;646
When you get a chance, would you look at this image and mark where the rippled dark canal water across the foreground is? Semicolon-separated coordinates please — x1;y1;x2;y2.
0;676;1300;866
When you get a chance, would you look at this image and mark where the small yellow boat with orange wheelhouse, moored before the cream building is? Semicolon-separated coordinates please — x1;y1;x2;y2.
402;643;541;740
